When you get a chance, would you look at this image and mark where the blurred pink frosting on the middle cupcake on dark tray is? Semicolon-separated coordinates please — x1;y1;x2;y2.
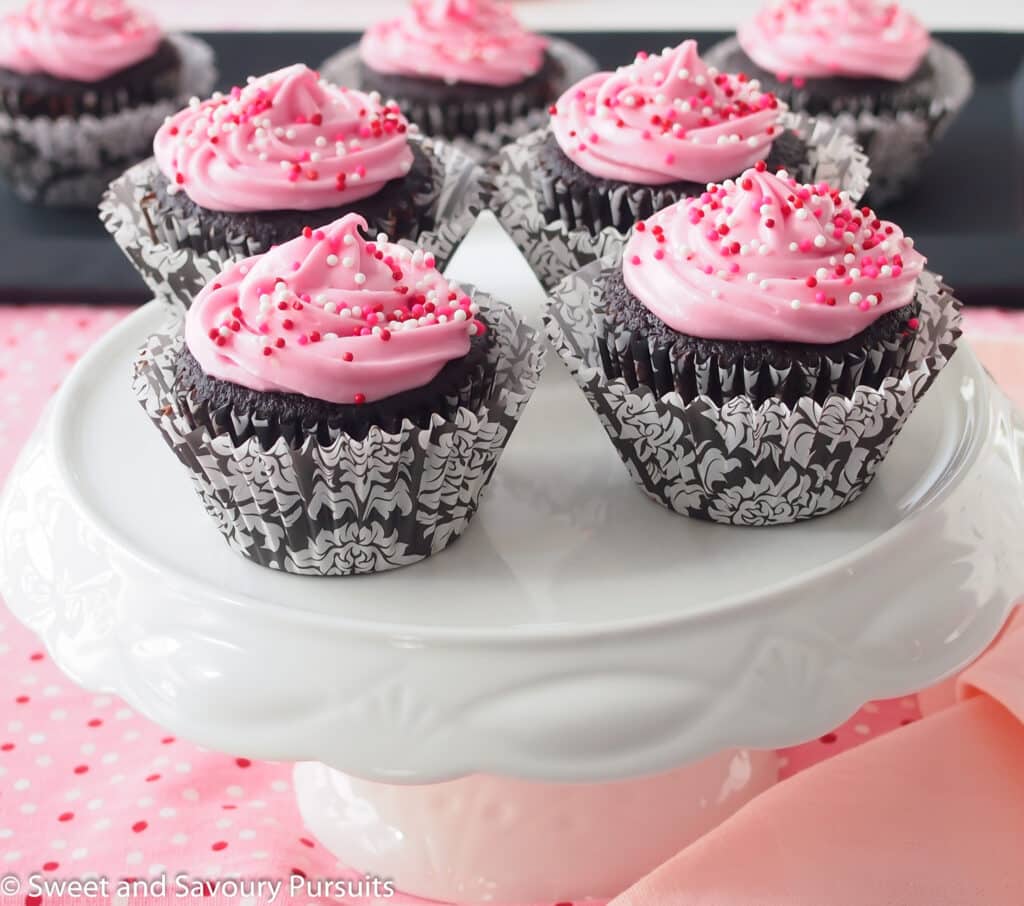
359;0;548;85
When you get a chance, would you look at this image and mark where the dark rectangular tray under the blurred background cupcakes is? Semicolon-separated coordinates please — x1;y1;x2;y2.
0;32;1024;308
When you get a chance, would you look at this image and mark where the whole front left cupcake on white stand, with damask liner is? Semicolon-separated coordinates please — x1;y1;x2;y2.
134;214;543;575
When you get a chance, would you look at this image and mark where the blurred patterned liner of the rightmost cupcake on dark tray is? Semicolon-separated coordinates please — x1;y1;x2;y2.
705;38;974;207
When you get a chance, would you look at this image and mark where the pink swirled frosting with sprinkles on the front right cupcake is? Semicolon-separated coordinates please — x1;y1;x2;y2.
623;165;925;345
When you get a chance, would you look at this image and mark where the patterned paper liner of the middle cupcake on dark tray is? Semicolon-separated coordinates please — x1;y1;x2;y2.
321;38;597;163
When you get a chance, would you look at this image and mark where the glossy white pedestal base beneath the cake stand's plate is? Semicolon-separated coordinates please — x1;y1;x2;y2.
295;749;777;903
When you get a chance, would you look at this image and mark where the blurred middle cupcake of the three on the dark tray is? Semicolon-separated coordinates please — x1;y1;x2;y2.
324;0;595;158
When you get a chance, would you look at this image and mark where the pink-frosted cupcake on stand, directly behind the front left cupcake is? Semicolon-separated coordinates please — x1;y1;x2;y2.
101;64;480;305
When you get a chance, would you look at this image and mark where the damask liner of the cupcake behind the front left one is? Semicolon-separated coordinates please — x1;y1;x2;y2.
99;137;488;308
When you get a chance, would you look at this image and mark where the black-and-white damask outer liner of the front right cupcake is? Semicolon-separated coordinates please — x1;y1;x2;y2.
545;259;962;526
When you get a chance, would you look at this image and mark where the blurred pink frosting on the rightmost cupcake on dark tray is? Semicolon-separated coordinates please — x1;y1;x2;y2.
738;0;931;82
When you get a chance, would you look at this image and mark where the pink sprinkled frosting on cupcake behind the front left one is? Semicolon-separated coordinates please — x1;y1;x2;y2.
154;64;413;212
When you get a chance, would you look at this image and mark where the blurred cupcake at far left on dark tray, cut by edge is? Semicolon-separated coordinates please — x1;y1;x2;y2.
0;0;214;206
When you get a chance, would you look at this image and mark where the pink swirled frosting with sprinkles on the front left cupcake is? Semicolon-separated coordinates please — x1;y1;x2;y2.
185;214;484;403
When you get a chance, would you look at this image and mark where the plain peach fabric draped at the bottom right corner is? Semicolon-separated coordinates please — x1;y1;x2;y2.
612;613;1024;906
